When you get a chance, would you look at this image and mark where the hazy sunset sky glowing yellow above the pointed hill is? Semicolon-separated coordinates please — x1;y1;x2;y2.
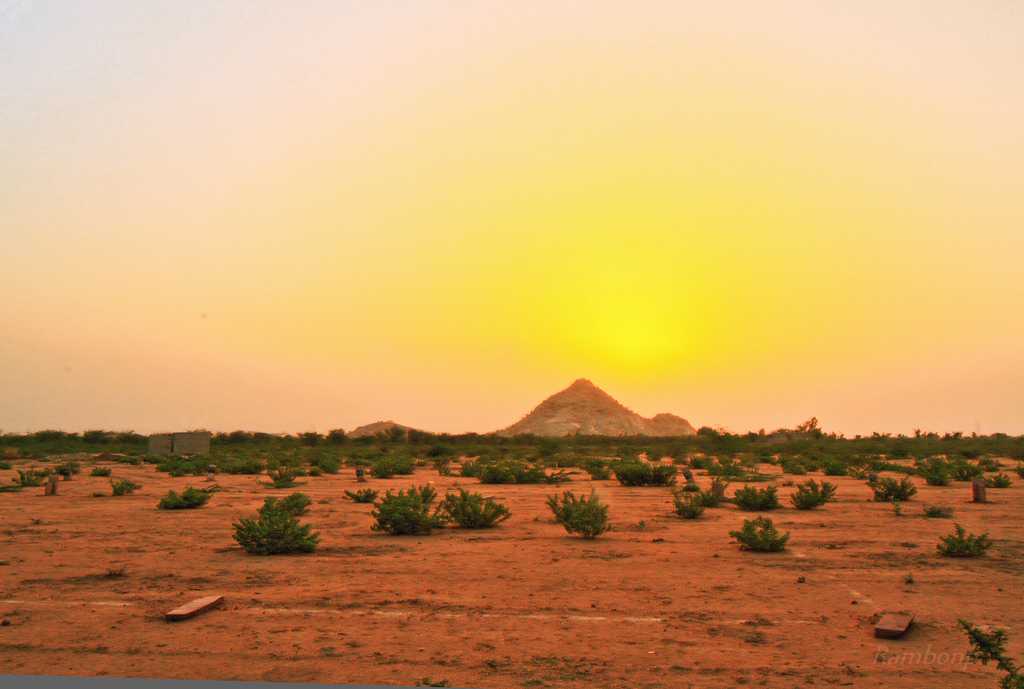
0;0;1024;435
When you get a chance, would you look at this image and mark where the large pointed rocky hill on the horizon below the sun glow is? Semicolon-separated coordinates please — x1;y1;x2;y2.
498;378;696;437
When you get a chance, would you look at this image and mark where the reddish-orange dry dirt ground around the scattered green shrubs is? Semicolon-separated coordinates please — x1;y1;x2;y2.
0;462;1024;689
